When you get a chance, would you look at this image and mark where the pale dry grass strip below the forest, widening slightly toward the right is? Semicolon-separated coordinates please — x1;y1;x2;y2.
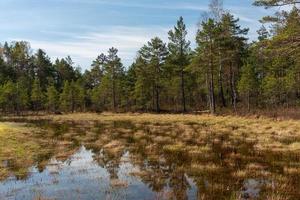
13;113;300;130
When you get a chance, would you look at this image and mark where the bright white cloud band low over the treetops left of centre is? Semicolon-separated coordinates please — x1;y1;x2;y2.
11;26;178;68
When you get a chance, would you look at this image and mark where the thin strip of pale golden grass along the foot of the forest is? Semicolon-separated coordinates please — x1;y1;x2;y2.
2;113;300;126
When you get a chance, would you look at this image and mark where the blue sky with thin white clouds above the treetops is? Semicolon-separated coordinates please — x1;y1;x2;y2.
0;0;269;70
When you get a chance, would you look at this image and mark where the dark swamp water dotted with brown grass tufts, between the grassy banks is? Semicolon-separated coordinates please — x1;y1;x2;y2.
0;121;300;200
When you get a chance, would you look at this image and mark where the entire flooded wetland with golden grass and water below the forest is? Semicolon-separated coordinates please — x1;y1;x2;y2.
0;113;300;200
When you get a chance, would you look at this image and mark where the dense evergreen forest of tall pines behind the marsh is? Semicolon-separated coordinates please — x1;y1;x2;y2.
0;0;300;114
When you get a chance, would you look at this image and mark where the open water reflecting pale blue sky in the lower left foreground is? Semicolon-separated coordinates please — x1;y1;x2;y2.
0;146;197;200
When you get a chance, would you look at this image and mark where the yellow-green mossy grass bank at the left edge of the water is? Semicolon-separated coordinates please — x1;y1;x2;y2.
0;122;78;181
